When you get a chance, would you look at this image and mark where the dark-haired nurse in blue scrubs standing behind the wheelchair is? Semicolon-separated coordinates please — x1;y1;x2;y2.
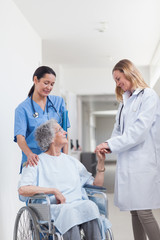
14;66;70;169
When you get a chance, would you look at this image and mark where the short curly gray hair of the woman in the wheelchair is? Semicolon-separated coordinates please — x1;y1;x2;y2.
35;119;57;152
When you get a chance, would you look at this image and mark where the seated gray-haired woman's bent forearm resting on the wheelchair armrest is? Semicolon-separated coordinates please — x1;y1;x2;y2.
18;185;66;203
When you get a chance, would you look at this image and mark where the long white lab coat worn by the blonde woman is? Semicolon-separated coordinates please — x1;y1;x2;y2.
107;88;160;210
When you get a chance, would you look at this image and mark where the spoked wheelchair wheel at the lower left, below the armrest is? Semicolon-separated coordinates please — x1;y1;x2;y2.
13;207;40;240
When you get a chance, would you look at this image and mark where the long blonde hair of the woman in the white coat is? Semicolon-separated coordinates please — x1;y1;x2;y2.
112;59;149;102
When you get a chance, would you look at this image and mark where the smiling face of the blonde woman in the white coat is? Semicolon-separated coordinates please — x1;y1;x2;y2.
113;70;132;92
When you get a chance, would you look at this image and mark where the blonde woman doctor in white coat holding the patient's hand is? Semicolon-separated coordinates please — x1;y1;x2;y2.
95;59;160;240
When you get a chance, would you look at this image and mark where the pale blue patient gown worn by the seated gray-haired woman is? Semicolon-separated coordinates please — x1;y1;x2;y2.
19;153;100;234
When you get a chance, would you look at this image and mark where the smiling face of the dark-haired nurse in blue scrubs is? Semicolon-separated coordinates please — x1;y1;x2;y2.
33;73;56;97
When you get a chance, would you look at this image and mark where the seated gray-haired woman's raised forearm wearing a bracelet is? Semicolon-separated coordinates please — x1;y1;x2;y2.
93;151;105;186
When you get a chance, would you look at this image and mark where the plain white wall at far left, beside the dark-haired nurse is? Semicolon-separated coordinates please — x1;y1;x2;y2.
0;0;41;240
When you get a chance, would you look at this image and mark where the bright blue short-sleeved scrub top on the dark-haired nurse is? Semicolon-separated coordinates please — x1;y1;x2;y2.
14;95;70;168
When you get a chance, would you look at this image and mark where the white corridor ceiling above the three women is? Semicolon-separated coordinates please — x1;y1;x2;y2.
13;0;160;67
